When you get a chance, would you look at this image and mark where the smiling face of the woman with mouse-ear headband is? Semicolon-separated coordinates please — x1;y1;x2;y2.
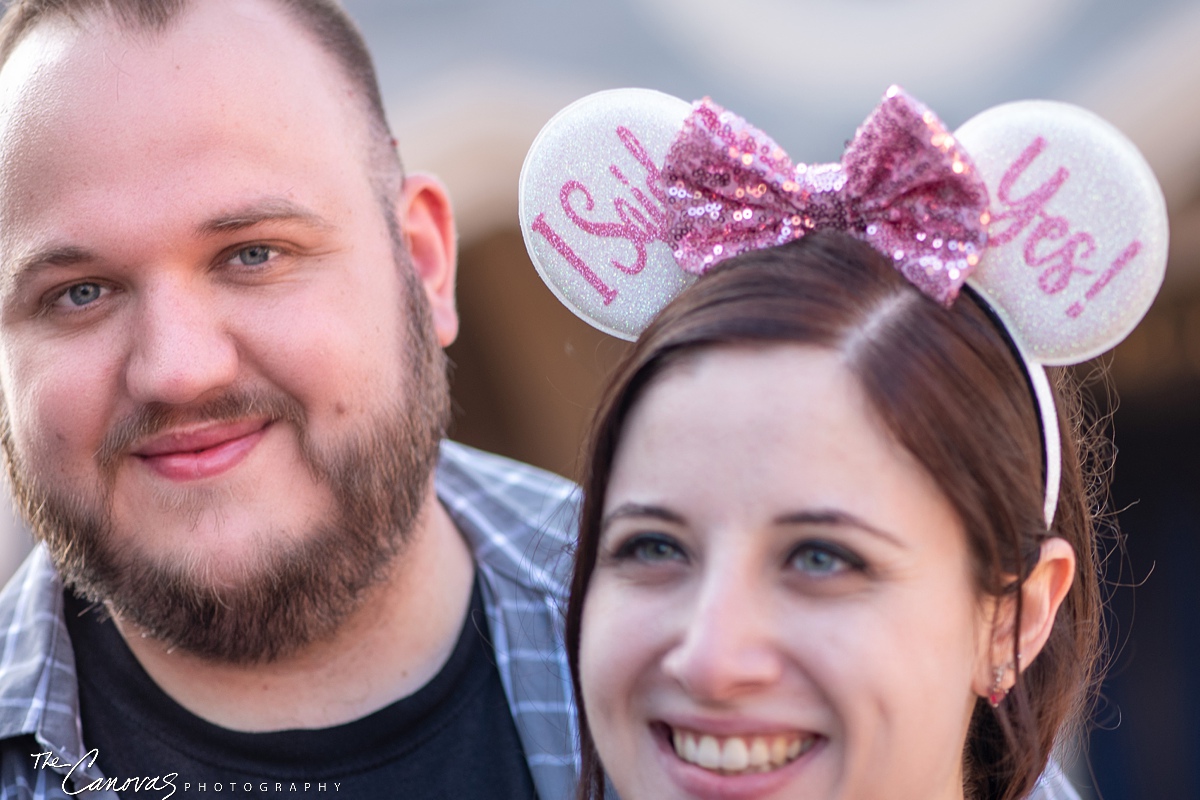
580;345;991;800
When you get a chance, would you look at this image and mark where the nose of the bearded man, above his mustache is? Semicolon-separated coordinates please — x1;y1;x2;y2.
125;277;239;405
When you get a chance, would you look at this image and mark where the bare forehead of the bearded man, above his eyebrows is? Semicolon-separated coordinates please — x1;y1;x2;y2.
0;0;366;192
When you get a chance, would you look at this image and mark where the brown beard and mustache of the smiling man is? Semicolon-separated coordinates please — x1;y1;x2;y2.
0;266;450;663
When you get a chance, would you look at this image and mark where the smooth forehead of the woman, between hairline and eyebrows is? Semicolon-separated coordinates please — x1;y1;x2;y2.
606;344;953;537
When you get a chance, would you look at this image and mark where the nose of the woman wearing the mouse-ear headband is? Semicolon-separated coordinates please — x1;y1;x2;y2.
662;567;784;703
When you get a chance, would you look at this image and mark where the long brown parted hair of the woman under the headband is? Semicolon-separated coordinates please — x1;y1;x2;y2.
566;233;1104;800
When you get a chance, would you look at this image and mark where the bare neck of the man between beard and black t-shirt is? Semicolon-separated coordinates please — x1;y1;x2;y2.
116;491;474;732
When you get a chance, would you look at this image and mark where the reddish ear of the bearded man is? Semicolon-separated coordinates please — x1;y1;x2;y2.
396;173;458;347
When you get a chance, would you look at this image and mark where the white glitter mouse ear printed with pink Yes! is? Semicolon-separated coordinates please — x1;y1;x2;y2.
955;101;1168;366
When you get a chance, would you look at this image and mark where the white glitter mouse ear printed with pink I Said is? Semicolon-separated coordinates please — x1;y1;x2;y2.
520;89;696;339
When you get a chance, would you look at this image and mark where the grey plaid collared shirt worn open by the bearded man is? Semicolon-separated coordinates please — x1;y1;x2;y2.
0;441;577;800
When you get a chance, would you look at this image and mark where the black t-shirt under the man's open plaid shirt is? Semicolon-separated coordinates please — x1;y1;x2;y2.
66;583;535;800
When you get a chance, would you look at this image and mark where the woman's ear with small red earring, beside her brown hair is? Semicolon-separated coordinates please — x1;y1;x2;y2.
973;536;1075;697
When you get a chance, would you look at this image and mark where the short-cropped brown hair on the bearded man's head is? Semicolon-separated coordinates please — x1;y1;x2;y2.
0;0;403;180
